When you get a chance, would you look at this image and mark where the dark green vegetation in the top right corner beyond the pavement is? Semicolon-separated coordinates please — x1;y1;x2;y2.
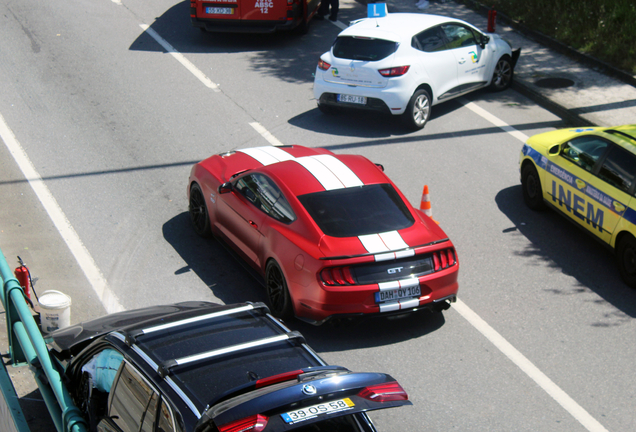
481;0;636;74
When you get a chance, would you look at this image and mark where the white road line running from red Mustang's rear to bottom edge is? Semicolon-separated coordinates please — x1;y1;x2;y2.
453;299;608;432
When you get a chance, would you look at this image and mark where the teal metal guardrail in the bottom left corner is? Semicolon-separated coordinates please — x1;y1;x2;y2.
0;249;88;432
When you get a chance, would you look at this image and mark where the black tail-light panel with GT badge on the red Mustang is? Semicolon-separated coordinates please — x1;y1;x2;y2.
320;248;457;286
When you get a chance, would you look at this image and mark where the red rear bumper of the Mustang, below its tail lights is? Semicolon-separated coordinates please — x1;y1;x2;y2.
290;264;459;325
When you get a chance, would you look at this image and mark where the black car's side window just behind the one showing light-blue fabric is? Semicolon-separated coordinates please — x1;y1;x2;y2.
108;363;157;431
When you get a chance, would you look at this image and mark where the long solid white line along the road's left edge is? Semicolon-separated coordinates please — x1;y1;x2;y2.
0;114;124;313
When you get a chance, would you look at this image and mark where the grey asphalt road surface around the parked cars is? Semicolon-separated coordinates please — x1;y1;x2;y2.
0;0;636;431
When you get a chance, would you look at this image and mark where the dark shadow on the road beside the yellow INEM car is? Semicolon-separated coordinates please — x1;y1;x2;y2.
495;185;636;326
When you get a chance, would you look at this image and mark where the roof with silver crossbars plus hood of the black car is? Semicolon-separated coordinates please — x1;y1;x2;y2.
51;302;324;413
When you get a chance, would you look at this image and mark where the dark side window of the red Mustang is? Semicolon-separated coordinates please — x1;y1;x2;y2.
235;174;296;223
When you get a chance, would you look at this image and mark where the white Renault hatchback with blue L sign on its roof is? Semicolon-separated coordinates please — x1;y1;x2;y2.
314;13;520;130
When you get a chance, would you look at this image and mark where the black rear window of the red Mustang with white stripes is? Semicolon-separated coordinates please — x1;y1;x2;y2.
298;183;414;237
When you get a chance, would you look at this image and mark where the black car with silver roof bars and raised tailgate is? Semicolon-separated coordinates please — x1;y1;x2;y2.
47;302;411;432
